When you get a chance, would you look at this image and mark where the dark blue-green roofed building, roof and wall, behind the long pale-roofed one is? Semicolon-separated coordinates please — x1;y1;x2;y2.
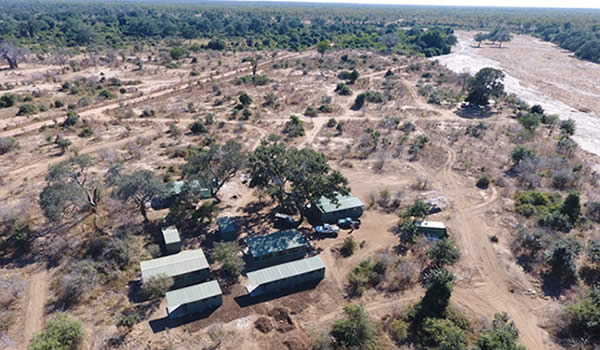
245;229;308;267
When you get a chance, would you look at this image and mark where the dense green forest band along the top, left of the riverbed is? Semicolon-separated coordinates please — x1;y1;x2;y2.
0;2;456;56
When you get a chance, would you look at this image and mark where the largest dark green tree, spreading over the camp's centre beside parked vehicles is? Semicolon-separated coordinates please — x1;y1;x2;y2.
248;137;350;219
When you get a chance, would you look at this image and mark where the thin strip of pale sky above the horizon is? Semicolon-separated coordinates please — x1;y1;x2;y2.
238;0;600;8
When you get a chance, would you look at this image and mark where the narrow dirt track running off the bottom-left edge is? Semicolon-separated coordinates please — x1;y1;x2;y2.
19;267;48;350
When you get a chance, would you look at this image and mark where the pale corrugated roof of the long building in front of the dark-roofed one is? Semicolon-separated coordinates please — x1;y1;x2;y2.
248;255;325;287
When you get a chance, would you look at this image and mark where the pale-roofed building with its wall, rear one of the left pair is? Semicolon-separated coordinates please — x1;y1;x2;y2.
140;249;210;288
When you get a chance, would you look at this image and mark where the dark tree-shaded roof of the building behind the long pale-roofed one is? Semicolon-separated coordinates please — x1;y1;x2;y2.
246;230;308;258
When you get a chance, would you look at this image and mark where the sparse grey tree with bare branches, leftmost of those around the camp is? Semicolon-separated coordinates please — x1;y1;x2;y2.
39;155;101;221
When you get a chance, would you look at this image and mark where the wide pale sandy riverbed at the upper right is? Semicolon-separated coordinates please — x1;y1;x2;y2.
435;31;600;169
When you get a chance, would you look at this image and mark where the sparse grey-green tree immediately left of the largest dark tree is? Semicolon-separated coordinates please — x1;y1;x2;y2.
183;140;247;200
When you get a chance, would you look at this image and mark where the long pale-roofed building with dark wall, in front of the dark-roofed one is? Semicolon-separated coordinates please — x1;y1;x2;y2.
246;255;325;296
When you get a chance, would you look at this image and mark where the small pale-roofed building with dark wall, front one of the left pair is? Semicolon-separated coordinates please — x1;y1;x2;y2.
167;281;223;319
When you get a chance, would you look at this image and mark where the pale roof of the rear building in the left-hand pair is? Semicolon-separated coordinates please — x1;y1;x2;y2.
140;249;209;280
